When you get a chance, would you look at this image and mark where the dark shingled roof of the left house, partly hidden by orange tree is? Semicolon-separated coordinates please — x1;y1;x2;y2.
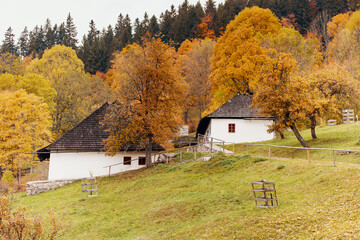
38;103;164;160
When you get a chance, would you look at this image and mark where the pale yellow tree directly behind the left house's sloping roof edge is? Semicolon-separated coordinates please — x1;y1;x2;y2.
26;45;107;136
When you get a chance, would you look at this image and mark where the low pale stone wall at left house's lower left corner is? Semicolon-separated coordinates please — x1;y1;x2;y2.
26;179;76;196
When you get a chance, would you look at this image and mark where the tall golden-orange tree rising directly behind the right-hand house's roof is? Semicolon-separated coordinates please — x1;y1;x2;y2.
211;7;281;110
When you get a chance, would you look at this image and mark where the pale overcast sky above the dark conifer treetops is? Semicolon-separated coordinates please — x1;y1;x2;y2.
0;0;224;41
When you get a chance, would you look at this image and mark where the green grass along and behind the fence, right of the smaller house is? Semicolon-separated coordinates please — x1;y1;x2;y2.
231;123;360;164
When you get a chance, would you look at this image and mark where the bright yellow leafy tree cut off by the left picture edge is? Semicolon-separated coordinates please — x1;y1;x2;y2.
0;90;51;174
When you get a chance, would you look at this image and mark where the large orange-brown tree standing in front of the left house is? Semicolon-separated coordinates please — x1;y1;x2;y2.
105;38;186;167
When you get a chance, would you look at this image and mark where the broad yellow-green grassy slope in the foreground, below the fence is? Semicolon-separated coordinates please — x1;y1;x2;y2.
18;125;360;239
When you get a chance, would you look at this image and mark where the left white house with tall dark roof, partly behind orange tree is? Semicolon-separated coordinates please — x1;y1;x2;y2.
38;104;164;180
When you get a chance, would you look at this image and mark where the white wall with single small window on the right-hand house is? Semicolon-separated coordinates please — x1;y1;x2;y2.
206;119;274;143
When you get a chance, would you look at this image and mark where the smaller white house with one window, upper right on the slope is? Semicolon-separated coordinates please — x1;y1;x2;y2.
196;94;274;143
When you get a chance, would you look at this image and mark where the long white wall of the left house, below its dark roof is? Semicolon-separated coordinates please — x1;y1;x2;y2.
49;152;155;180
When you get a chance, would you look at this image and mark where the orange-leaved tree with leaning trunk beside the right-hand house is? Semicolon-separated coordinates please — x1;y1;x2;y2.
253;53;308;147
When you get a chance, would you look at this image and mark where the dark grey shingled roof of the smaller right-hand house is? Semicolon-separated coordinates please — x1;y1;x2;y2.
196;93;272;136
